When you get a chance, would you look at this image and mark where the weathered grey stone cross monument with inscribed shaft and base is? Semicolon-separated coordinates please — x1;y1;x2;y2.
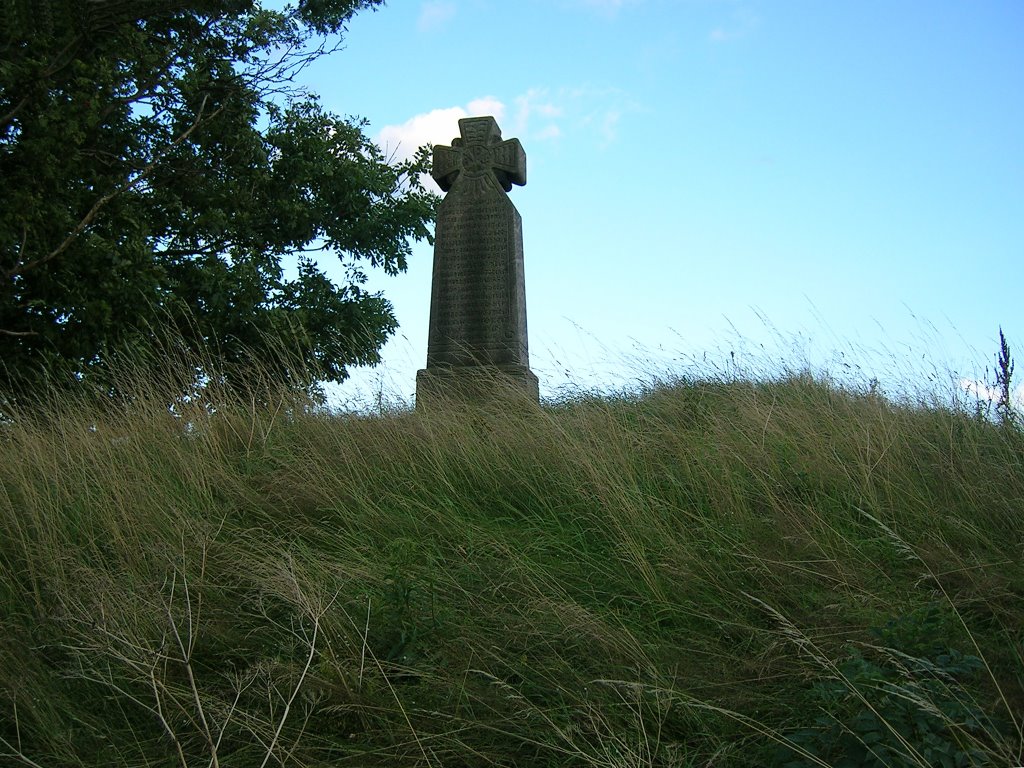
416;117;538;406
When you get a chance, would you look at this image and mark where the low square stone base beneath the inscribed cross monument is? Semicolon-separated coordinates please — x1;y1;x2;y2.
416;366;540;409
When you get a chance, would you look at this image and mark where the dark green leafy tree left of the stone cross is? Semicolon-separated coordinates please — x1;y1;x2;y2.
0;0;437;397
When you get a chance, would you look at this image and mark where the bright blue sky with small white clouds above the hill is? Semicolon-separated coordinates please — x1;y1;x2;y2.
284;0;1024;398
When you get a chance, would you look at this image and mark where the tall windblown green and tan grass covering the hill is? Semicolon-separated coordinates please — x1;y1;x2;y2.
0;364;1024;768
